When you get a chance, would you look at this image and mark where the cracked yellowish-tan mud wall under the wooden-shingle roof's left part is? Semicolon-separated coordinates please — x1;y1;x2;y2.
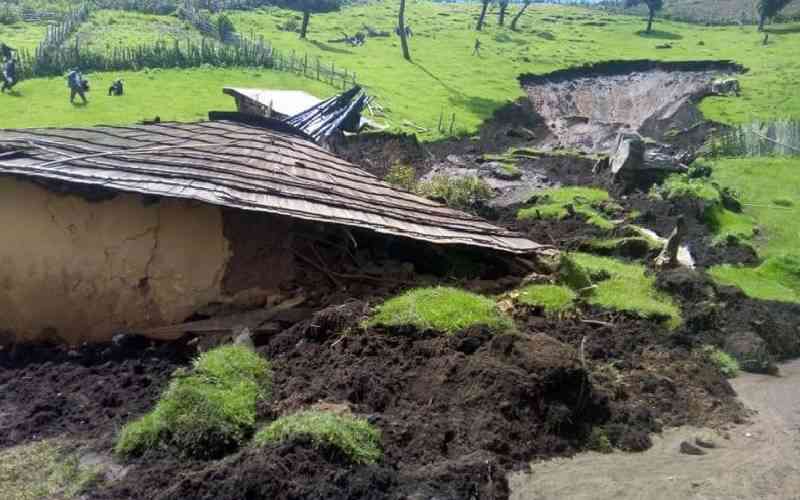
0;177;232;343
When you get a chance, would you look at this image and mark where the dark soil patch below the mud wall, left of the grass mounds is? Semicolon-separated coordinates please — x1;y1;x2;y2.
0;337;188;447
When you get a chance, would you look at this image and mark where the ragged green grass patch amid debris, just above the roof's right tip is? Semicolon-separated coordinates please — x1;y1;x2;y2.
517;186;614;229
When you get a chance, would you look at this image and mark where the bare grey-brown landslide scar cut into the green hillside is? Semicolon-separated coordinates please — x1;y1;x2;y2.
520;61;742;152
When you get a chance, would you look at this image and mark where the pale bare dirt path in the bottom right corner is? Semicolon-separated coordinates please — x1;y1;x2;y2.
509;360;800;500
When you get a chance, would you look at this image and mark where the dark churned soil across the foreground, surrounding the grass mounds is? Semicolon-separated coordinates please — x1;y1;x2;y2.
0;302;741;499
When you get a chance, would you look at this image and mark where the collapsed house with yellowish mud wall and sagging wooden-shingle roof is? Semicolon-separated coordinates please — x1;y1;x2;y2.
0;113;539;344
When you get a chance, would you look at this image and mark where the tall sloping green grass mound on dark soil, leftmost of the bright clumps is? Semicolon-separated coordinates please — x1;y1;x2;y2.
115;345;272;458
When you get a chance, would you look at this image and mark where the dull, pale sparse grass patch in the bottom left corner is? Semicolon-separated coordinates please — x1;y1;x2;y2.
0;440;98;500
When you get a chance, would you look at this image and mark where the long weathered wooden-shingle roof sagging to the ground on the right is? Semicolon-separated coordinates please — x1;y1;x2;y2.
0;119;540;254
